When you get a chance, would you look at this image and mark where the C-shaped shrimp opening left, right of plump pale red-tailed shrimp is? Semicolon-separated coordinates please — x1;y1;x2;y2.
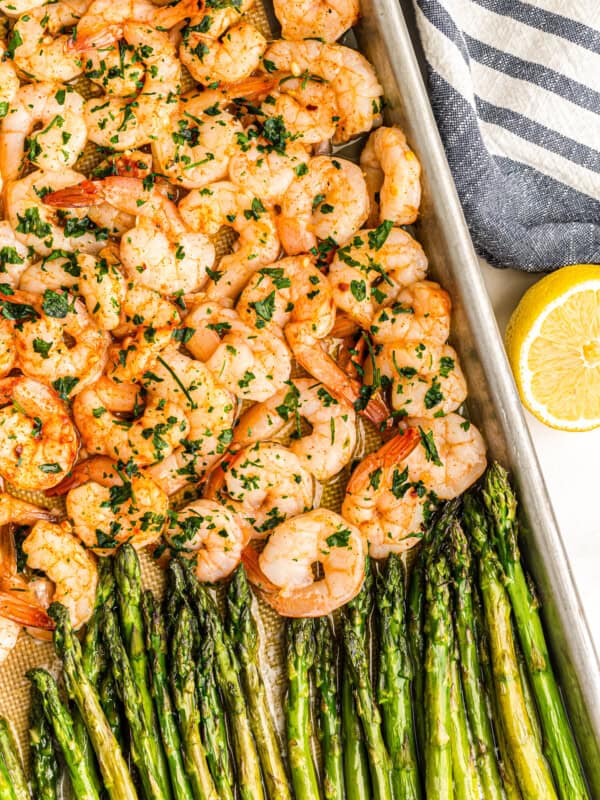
179;181;279;300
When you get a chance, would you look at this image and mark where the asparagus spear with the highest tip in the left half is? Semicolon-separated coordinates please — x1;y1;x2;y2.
114;544;172;800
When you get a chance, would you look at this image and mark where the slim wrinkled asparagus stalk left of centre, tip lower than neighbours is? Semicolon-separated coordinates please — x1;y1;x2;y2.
196;637;234;800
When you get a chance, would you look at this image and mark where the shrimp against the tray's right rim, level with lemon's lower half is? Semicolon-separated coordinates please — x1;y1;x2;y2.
365;342;467;417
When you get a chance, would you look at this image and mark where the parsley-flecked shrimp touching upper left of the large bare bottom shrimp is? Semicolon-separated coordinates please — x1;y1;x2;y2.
204;442;318;538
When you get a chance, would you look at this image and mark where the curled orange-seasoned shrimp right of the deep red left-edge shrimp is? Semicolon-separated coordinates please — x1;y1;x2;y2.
73;378;189;466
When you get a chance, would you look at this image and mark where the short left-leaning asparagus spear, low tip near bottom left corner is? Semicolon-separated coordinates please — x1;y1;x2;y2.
27;669;101;800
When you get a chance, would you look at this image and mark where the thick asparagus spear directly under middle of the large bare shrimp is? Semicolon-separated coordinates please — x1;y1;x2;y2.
285;619;321;800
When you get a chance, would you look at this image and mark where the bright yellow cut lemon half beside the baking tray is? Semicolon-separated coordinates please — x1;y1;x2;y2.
506;264;600;431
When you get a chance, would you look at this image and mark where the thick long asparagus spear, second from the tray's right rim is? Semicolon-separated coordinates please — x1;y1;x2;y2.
464;495;557;800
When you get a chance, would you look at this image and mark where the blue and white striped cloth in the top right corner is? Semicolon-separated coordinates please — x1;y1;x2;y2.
414;0;600;272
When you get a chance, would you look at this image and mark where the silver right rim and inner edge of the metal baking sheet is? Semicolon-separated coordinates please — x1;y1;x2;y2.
356;0;600;797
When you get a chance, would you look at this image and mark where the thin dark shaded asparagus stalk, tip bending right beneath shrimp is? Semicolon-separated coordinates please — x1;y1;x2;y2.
407;500;460;760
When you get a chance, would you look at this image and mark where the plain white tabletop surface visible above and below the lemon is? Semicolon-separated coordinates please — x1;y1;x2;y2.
481;261;600;653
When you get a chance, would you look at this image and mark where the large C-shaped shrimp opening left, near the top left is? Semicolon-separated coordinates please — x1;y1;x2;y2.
84;23;181;150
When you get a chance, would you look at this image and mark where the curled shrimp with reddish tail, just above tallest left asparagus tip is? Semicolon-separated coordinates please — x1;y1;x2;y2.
50;456;169;556
